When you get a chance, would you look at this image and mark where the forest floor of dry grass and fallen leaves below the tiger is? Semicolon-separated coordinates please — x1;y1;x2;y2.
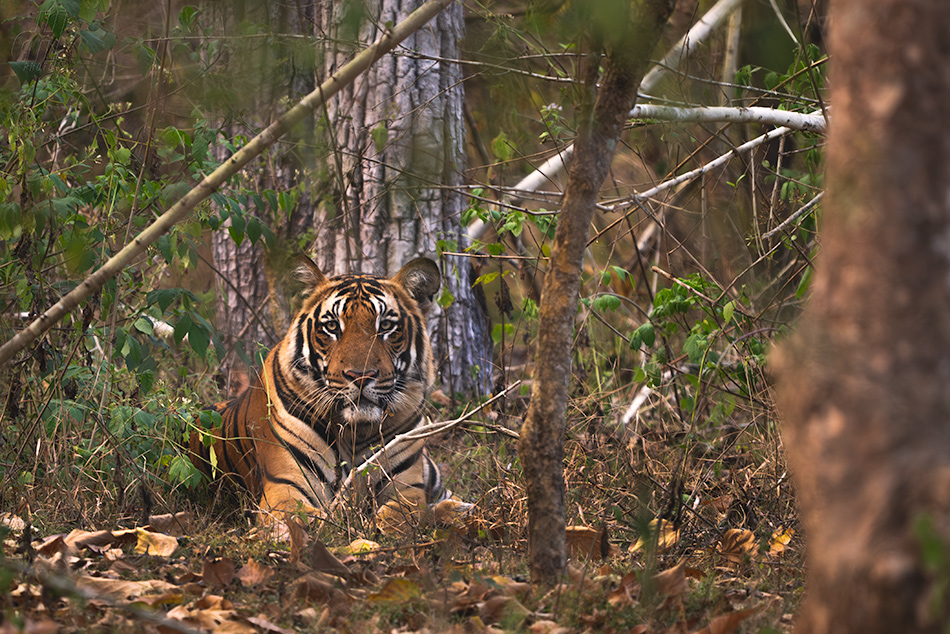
0;382;804;634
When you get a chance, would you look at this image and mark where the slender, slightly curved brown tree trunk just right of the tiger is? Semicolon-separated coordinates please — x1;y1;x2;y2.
519;0;675;585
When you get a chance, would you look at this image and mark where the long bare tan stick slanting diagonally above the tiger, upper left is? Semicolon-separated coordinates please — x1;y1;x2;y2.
0;0;452;368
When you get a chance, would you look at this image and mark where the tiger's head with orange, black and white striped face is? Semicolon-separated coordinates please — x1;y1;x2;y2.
278;258;440;435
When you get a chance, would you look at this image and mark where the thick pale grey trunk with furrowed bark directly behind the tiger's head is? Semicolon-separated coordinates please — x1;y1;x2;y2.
314;0;492;394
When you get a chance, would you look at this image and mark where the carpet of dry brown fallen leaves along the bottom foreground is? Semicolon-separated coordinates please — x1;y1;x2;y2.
0;516;794;634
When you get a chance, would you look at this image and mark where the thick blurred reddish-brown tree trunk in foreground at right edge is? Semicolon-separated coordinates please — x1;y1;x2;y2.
775;0;950;634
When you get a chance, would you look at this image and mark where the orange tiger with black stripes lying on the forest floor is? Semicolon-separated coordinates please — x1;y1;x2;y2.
190;256;452;526
